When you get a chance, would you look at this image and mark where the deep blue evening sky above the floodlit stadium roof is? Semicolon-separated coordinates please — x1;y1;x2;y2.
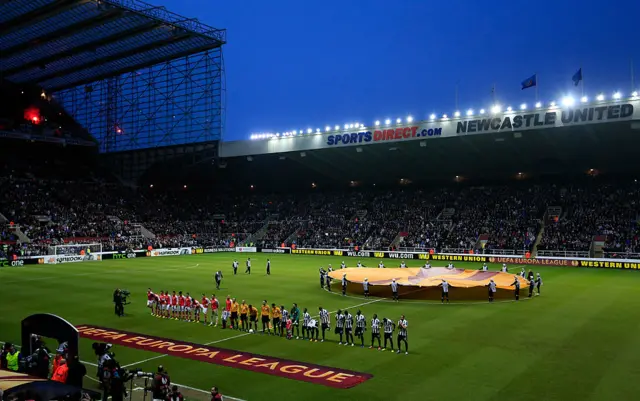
148;0;640;140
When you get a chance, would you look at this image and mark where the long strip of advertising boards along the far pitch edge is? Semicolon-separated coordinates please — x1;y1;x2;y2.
5;247;640;270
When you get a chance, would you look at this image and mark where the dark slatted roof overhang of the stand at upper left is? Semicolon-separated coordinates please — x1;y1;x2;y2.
0;0;226;91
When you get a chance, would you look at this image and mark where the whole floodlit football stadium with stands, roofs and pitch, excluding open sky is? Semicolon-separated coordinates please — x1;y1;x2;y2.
0;0;640;401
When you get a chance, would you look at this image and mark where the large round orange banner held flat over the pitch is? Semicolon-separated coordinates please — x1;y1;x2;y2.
329;266;529;302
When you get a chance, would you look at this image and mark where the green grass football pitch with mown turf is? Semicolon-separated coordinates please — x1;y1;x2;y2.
0;253;640;401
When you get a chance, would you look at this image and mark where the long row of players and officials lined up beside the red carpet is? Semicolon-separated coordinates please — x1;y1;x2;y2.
147;288;409;354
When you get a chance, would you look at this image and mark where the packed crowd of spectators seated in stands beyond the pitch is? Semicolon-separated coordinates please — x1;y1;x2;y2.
0;165;640;255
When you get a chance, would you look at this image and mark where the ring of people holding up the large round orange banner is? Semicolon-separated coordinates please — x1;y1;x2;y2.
319;261;542;303
